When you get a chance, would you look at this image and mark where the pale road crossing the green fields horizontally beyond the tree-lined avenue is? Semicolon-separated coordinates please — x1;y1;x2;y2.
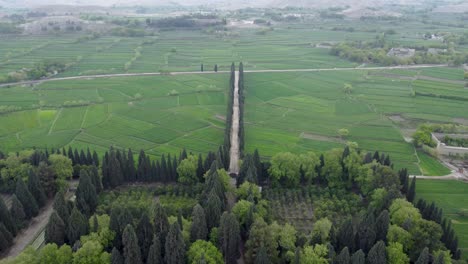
0;64;448;87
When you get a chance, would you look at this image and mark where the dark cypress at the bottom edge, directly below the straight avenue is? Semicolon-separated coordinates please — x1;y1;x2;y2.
219;212;240;264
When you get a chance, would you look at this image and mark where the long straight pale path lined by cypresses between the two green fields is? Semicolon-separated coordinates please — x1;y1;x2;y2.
229;71;239;174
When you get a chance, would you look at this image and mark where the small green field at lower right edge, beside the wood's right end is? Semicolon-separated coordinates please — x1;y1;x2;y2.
416;180;468;256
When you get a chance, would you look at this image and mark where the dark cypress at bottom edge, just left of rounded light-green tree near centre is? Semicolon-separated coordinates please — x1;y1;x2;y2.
164;222;185;264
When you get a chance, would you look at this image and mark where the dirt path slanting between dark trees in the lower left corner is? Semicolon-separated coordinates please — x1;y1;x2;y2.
5;200;54;258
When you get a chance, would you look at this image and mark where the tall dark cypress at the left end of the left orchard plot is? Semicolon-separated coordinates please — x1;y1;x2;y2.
76;170;98;216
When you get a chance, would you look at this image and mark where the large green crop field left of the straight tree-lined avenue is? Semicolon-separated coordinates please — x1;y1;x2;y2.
0;74;228;156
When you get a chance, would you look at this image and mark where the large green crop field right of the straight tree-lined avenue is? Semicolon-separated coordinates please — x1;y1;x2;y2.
245;70;468;175
